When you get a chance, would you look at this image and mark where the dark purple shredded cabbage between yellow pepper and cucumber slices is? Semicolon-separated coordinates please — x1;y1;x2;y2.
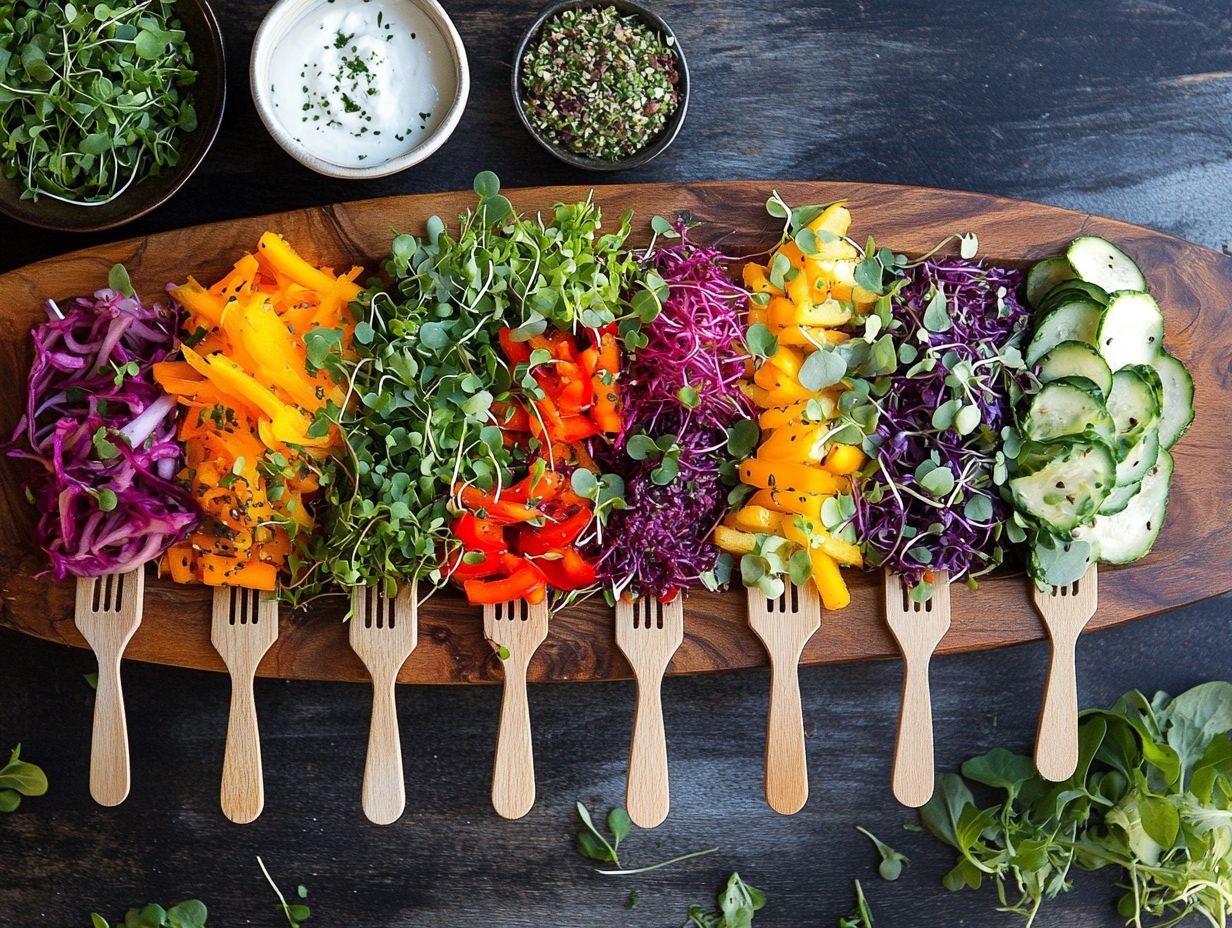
854;258;1029;590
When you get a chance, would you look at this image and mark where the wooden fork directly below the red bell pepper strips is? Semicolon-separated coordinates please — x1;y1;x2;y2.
483;599;547;818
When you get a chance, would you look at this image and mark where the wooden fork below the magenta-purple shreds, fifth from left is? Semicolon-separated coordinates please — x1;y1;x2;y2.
616;594;685;828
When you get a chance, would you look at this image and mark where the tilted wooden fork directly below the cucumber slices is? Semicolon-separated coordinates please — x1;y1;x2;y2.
1031;564;1099;781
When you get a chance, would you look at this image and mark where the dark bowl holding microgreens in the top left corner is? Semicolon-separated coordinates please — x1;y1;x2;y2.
0;0;227;232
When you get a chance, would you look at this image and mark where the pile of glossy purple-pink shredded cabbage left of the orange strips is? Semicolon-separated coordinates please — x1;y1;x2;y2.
9;280;200;580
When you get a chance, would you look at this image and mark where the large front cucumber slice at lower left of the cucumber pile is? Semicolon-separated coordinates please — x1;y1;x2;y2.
1009;439;1116;534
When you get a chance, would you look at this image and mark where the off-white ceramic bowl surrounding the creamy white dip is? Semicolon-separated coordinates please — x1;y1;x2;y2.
248;0;471;180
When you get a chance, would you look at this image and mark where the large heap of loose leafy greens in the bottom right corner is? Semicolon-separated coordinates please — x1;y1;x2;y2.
920;683;1232;926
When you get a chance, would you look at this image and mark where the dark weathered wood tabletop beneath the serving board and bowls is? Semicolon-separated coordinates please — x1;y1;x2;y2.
0;0;1232;928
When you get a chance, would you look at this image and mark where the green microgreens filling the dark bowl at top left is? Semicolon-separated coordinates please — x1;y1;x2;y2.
0;0;197;203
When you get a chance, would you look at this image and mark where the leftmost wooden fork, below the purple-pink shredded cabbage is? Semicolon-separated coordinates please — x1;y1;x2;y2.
73;567;145;806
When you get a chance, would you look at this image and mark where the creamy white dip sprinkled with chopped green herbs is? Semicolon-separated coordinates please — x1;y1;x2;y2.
270;0;457;168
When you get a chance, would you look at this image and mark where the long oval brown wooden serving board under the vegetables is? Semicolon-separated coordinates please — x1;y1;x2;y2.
0;181;1232;683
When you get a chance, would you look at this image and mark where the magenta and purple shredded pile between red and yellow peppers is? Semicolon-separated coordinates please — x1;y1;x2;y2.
595;227;752;600
